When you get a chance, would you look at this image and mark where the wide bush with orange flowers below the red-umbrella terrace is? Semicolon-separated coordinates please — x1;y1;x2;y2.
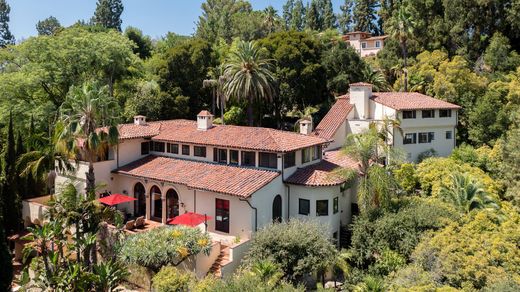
120;226;211;272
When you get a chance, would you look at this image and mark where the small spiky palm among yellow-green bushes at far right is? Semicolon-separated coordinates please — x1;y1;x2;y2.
441;173;499;213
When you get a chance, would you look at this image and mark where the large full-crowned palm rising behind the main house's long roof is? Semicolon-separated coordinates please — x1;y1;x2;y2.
224;41;276;126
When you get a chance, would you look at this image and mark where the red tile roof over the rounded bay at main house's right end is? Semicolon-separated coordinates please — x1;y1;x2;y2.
285;150;359;187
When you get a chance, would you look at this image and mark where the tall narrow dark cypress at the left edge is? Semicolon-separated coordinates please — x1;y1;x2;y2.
2;113;21;234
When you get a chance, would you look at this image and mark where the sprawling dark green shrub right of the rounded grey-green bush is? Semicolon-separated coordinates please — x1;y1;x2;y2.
350;198;458;267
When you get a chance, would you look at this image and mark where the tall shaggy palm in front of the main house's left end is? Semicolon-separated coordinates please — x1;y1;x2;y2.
56;83;119;193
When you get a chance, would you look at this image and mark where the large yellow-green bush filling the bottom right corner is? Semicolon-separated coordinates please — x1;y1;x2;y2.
412;206;520;289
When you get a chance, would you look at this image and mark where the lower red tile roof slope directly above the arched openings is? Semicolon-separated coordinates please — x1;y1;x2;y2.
114;155;280;198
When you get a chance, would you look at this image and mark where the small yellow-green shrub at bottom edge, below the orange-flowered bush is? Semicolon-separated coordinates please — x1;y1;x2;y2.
152;266;194;292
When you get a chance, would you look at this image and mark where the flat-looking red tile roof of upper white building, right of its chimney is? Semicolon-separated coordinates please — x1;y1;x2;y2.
371;92;460;110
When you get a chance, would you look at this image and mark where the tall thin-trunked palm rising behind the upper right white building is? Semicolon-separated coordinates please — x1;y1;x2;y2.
386;5;415;91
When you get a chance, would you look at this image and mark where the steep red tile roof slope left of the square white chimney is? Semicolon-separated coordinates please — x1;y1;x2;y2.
313;97;354;140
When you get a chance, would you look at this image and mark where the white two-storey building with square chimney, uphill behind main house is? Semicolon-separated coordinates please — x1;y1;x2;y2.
314;83;460;161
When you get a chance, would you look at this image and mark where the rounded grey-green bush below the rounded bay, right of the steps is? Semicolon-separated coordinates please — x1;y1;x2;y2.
246;219;337;280
